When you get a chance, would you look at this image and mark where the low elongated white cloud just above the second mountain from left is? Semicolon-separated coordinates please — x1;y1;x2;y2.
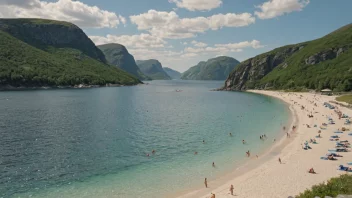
90;34;166;48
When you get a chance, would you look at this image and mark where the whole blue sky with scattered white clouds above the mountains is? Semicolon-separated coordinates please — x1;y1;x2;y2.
0;0;352;72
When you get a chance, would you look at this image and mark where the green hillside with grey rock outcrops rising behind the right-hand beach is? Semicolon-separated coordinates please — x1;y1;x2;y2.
223;24;352;91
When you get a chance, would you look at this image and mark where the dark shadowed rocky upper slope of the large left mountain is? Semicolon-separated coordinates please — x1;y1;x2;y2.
0;19;106;63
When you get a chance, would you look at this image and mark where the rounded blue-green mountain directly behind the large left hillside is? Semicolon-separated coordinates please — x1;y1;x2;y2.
98;43;150;80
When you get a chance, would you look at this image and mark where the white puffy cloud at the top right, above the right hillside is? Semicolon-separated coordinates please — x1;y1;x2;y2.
255;0;310;19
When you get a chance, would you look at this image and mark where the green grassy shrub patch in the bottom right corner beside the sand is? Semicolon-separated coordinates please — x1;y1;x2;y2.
296;174;352;198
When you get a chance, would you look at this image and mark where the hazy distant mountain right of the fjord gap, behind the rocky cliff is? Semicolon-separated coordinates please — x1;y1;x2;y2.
181;56;239;80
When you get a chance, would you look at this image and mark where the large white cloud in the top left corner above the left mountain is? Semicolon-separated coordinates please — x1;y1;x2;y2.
0;0;126;28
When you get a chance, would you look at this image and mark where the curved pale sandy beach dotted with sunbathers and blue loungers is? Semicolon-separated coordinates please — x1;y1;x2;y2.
180;91;352;198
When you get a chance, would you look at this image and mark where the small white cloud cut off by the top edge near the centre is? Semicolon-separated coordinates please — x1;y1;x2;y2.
169;0;222;11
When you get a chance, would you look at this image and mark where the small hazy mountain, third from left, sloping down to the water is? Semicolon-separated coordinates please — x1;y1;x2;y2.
137;59;171;80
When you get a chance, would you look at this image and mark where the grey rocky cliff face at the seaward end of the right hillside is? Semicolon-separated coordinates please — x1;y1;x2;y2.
223;45;304;90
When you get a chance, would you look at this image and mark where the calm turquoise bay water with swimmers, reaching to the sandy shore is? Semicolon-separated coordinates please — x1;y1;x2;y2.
0;81;289;198
